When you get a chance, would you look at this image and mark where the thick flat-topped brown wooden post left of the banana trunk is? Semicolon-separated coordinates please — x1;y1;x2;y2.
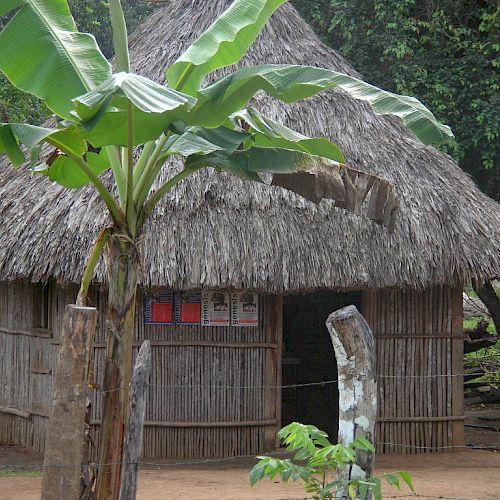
42;305;97;500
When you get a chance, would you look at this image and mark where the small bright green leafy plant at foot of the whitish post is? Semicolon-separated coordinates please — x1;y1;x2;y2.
250;422;414;500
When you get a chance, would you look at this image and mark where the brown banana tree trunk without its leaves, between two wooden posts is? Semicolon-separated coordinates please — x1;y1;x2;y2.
96;232;139;500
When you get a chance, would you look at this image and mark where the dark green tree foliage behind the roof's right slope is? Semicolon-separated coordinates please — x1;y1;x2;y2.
293;0;500;200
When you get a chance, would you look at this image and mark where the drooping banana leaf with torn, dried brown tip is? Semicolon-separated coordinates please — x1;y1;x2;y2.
173;114;399;230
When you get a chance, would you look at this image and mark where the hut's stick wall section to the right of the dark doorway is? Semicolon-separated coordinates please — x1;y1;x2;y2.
363;287;464;454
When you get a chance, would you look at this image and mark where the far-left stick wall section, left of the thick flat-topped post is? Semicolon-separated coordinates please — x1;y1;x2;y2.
0;283;60;451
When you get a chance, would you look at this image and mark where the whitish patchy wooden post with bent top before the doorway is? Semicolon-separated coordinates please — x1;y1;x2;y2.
326;306;377;498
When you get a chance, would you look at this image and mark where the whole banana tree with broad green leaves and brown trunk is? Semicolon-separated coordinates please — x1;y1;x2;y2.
0;0;452;498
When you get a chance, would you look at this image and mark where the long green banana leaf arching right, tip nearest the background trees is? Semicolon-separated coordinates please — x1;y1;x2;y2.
192;65;453;145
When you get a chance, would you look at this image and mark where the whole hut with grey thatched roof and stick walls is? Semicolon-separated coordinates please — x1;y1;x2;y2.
0;0;500;457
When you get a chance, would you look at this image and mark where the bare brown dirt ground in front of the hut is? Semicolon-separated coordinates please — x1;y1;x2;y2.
0;405;500;500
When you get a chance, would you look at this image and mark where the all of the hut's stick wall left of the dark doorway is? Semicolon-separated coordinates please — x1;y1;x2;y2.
0;284;282;459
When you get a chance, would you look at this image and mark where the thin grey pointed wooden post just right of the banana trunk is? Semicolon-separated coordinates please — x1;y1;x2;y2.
120;340;151;500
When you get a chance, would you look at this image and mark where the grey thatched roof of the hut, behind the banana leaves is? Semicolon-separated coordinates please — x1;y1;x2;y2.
0;0;500;292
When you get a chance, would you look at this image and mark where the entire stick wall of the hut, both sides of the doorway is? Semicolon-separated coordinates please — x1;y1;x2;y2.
0;283;463;459
